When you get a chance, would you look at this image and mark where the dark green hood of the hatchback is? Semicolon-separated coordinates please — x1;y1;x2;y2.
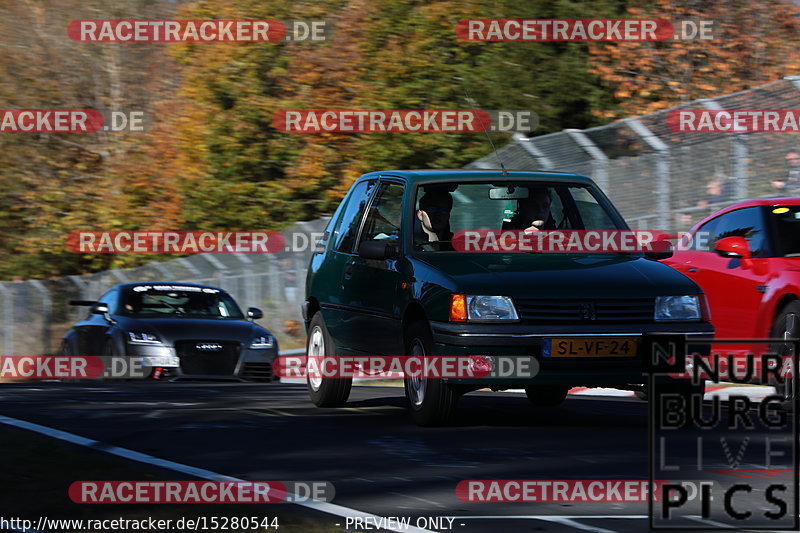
418;253;701;298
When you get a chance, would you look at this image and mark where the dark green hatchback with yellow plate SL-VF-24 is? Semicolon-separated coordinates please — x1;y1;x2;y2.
302;170;713;425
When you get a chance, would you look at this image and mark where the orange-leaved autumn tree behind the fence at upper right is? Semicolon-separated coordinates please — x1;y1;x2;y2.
590;0;800;119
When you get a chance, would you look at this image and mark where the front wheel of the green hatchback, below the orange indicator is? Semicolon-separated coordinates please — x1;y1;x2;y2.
404;322;458;427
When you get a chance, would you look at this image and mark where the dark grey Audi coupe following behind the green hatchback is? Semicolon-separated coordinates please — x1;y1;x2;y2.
61;282;278;381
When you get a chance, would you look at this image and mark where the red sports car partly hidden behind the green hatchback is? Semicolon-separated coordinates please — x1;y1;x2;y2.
664;198;800;397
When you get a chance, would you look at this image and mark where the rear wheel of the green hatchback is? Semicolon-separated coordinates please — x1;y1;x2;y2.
306;311;353;407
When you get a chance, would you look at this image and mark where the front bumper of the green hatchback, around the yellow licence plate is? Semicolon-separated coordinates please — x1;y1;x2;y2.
424;322;714;387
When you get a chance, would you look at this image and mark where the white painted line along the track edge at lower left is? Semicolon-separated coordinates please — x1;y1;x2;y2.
0;415;436;533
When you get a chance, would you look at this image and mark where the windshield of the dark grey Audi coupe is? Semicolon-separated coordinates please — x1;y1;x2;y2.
120;285;244;319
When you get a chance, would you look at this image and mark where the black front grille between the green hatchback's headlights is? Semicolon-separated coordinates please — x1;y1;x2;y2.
514;298;655;324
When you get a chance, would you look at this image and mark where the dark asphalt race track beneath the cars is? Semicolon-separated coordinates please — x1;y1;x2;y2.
0;382;788;533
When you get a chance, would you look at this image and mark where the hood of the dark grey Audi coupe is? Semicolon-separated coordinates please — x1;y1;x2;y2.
119;317;265;344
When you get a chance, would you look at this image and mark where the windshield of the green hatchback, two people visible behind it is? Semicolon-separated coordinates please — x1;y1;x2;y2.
414;181;627;251
